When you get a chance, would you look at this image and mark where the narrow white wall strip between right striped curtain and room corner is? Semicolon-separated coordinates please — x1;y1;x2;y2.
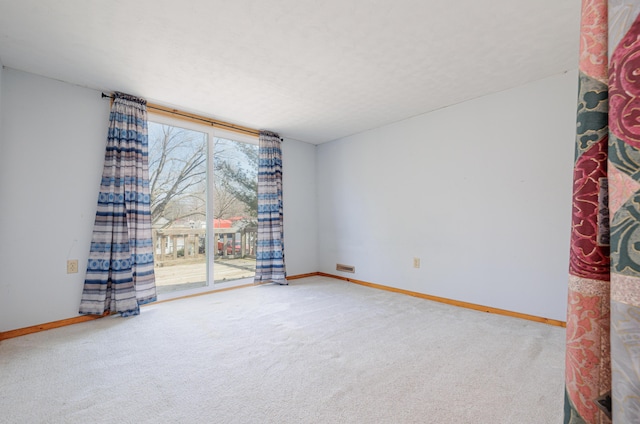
282;139;318;276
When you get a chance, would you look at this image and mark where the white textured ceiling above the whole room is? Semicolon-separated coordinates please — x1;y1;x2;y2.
0;0;580;143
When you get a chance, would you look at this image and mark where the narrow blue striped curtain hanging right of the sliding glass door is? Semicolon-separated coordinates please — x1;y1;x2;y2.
255;131;287;284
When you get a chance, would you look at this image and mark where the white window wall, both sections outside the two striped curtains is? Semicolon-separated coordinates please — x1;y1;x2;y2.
0;69;317;331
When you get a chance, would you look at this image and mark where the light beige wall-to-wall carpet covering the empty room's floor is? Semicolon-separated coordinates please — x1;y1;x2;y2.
0;277;564;424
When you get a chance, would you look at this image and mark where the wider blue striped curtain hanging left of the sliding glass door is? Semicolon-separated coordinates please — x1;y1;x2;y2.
80;93;156;316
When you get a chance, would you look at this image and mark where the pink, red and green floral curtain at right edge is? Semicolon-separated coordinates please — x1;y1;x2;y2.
564;0;640;424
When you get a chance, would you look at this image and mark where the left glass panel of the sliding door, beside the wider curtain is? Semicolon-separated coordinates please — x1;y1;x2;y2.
149;121;208;294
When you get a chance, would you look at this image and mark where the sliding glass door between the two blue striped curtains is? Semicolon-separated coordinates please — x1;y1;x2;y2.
149;115;258;297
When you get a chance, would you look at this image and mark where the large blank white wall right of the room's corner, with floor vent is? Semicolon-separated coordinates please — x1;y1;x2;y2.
317;72;577;320
